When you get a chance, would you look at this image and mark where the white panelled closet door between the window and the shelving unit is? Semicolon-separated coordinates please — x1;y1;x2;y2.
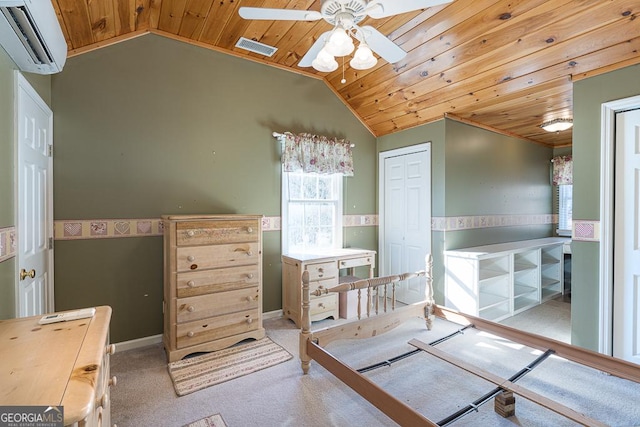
379;144;431;303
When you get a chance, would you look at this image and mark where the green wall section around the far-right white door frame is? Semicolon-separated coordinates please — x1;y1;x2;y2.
571;65;640;350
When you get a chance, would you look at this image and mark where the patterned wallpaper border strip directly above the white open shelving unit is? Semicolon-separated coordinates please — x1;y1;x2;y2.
431;214;558;231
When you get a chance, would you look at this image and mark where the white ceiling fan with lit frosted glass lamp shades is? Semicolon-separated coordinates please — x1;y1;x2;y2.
239;0;453;72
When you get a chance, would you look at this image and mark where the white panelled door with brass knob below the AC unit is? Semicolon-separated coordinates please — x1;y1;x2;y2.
16;72;53;317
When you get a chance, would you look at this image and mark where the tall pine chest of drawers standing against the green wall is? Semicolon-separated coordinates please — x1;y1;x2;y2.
162;215;265;362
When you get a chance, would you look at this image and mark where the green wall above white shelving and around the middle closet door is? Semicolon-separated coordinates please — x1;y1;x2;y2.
378;119;553;304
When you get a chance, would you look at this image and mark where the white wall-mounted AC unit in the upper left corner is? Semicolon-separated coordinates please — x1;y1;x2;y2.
0;0;67;74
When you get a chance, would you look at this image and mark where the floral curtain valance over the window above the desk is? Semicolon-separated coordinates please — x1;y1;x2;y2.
282;133;353;176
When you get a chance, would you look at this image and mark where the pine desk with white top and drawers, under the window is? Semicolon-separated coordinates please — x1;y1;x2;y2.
282;248;376;327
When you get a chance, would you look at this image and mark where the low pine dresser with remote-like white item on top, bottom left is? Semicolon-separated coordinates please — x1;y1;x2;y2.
0;306;116;427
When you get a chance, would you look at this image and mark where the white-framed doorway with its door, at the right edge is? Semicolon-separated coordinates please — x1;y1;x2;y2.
599;96;640;364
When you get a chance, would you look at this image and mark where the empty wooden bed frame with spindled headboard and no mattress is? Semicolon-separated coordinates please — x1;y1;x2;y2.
300;255;640;426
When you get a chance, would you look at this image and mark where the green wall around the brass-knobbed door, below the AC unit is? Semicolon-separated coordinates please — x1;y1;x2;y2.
0;47;51;319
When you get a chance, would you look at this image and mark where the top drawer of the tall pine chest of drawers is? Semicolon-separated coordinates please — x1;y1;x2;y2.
176;220;260;246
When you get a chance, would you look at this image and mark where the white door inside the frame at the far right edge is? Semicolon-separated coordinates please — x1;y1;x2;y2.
613;110;640;364
